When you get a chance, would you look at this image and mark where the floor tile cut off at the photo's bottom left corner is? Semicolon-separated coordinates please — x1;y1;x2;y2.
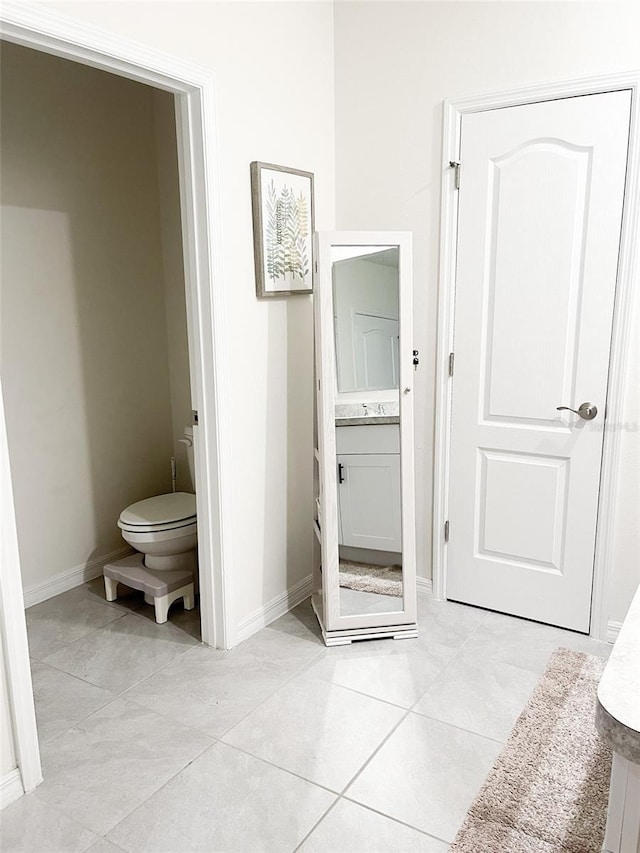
0;794;97;853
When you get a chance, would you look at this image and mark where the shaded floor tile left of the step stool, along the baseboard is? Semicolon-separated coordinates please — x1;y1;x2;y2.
26;587;123;660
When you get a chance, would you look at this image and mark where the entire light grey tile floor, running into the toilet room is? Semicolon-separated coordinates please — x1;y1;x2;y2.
0;580;609;853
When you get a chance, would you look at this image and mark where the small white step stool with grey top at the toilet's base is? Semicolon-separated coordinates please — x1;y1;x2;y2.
103;554;196;625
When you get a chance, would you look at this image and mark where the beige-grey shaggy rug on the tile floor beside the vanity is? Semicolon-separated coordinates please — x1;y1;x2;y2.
449;649;611;853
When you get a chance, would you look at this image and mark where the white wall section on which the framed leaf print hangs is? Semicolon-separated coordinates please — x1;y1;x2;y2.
44;2;334;621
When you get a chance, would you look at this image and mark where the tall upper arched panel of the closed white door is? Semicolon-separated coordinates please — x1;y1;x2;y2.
482;140;591;421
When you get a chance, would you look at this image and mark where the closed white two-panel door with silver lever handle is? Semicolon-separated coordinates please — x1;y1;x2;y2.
446;91;631;632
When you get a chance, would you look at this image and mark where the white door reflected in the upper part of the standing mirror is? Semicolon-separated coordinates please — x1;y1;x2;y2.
352;312;398;390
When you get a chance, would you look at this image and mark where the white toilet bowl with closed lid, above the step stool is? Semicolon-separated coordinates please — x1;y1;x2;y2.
118;492;198;573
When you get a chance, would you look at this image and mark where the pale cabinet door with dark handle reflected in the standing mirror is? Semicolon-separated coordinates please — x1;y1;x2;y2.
338;453;402;552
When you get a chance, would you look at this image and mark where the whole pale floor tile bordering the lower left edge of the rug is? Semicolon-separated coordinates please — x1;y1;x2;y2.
345;713;500;842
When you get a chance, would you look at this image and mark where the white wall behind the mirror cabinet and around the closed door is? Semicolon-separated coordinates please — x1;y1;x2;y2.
335;2;640;620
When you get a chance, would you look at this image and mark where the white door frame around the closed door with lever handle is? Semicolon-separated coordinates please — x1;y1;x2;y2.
432;71;640;640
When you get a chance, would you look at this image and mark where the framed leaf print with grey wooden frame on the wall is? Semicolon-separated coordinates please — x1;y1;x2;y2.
251;162;314;297
